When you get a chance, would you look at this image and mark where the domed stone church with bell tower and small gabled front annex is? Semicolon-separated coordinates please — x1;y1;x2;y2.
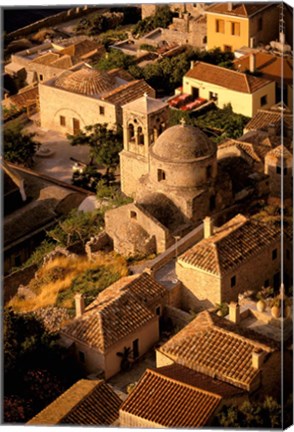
105;101;232;256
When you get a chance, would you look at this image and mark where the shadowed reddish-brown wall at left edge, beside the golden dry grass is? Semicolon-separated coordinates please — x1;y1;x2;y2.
3;264;38;305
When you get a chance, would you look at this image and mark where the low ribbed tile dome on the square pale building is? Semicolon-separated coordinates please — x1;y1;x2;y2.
55;67;115;96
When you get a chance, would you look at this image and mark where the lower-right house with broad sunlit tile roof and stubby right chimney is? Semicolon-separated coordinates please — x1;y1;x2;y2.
156;311;282;399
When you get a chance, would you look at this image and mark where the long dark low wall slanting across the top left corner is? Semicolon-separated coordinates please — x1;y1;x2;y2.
8;5;100;38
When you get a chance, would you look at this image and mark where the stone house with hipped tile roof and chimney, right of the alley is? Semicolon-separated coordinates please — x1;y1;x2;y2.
176;214;281;310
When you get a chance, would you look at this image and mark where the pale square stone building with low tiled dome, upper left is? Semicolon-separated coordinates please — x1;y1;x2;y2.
39;64;155;134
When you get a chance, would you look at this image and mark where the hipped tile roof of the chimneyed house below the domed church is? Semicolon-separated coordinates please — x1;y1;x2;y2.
178;214;281;275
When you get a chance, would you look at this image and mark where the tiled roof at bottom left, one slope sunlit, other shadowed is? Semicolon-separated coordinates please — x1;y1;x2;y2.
27;379;122;426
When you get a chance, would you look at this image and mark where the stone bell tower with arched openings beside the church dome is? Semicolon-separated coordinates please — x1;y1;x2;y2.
120;94;168;197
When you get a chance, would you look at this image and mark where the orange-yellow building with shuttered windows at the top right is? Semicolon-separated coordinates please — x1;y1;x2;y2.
206;2;279;52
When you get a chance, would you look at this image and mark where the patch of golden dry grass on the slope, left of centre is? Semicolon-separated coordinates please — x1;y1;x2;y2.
8;253;128;312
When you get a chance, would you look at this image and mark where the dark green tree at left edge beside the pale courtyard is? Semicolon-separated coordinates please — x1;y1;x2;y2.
3;124;40;166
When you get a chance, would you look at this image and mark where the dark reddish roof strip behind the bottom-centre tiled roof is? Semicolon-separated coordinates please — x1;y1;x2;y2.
156;363;245;398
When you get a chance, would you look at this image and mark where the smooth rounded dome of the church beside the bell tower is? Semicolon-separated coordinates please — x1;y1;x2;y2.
152;124;216;160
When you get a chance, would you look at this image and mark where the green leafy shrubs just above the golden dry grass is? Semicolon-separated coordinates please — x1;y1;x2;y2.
47;209;104;247
